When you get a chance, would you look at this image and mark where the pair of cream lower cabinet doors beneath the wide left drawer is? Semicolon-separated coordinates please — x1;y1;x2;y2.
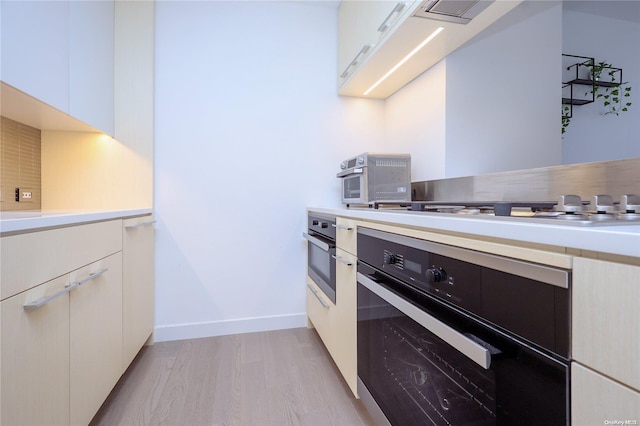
1;252;122;426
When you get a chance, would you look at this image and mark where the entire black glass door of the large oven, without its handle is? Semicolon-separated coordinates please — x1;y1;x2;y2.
357;278;569;425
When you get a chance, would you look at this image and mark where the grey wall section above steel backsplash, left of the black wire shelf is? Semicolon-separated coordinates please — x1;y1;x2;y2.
445;1;562;177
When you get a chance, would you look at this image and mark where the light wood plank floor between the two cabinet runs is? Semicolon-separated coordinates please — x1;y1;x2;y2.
91;328;373;426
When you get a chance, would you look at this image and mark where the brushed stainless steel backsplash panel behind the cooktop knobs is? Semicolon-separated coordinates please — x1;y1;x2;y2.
411;158;640;202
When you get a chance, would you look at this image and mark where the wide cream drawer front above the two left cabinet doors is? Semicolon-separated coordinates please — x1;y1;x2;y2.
0;219;122;299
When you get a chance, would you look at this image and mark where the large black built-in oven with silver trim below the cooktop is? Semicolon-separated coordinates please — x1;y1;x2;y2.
357;228;570;426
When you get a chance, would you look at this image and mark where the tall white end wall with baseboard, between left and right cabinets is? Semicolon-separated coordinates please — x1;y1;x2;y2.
155;1;384;340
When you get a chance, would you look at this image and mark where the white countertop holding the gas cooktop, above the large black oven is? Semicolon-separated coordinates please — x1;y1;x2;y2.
307;207;640;258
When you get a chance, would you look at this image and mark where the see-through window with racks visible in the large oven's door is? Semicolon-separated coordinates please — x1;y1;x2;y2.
358;286;496;425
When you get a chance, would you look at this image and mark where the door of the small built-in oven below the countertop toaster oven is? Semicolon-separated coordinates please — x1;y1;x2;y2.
303;232;336;303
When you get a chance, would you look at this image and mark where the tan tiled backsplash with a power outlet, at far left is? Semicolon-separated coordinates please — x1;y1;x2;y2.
0;117;42;211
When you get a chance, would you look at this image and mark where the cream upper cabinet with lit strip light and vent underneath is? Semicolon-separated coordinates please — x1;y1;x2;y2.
338;0;522;99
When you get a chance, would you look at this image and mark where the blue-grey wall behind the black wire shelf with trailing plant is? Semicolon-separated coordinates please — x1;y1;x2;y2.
562;2;640;164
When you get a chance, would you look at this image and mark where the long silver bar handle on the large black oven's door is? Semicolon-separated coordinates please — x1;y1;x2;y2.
358;272;491;370
